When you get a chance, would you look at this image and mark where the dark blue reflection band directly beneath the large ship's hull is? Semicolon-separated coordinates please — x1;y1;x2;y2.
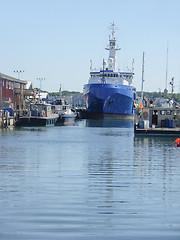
86;119;134;128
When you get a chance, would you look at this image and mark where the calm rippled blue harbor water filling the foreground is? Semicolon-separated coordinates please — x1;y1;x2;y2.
0;120;180;240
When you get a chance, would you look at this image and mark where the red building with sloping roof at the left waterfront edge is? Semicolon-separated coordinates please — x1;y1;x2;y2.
0;73;27;110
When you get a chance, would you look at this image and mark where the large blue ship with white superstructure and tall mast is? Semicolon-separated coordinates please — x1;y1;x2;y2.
83;23;136;117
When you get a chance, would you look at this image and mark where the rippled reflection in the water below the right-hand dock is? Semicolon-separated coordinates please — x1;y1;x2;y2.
133;137;180;210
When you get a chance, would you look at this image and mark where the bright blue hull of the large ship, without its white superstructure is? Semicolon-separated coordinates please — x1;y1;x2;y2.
84;84;136;117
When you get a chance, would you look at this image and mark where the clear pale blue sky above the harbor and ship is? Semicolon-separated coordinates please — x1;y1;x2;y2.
0;0;180;92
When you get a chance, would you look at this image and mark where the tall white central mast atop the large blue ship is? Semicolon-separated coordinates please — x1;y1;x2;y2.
105;22;120;71
